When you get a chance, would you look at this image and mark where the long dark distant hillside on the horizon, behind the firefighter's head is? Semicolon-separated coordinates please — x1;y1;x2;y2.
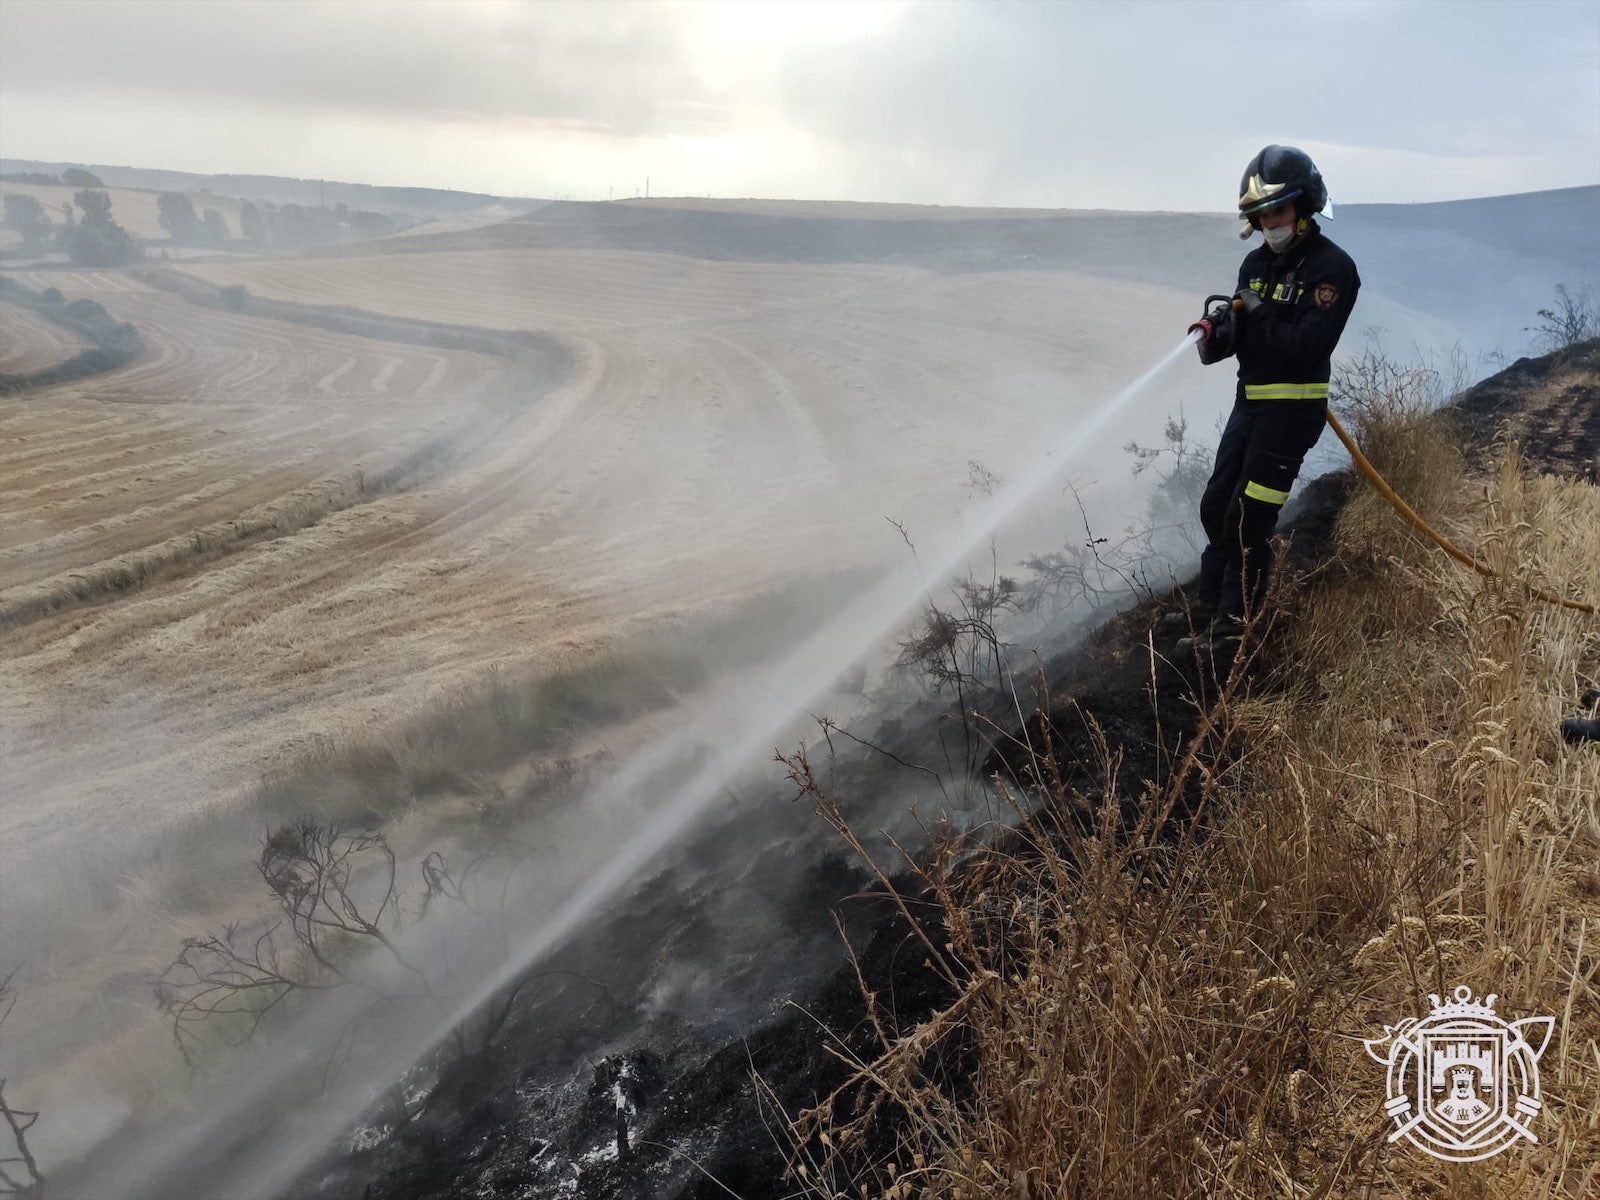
334;187;1600;283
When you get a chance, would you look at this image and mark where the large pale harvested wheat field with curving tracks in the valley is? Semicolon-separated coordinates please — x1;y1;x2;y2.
0;240;1190;1113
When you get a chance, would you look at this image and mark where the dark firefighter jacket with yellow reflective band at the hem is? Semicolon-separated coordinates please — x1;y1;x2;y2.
1200;221;1362;403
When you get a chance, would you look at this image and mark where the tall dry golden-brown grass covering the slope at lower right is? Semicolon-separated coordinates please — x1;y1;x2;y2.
794;410;1600;1200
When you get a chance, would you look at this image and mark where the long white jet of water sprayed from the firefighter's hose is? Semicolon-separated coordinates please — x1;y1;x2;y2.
80;330;1202;1200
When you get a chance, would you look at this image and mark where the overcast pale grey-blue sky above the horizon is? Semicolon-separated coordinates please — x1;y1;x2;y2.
0;0;1600;211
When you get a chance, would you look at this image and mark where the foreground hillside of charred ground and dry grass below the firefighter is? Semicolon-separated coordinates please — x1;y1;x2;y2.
240;342;1600;1200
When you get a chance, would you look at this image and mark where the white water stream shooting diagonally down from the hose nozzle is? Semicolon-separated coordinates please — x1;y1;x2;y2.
46;331;1192;1200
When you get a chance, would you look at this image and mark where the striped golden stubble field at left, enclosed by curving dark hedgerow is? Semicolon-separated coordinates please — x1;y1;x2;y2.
0;272;524;633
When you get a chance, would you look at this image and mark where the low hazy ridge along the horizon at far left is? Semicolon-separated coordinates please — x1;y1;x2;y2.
0;158;546;216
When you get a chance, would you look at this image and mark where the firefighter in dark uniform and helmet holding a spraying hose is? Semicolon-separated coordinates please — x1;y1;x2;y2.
1184;146;1362;662
